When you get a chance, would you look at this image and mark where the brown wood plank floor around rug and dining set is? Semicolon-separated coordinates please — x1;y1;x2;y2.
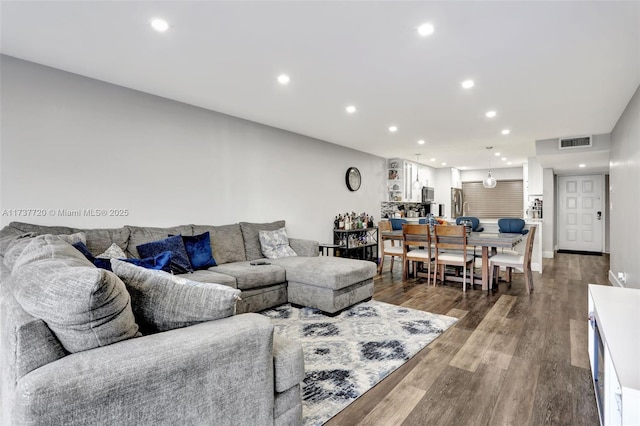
327;254;609;426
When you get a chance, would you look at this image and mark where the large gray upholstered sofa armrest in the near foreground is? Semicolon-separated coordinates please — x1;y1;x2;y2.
12;314;274;425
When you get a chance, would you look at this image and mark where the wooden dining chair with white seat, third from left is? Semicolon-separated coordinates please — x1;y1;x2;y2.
434;225;475;291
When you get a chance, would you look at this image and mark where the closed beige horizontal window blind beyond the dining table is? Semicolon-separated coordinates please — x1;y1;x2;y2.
462;180;524;219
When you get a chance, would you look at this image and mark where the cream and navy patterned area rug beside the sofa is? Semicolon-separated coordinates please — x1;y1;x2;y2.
260;300;457;426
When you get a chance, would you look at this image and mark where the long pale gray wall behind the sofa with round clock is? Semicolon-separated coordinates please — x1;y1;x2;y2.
0;56;386;242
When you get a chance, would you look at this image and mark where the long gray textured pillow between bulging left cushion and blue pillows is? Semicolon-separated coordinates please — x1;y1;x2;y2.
111;259;240;333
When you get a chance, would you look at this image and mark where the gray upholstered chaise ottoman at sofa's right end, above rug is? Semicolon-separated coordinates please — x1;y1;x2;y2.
282;256;377;314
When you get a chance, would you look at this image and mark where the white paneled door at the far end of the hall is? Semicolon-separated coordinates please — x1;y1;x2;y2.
558;175;604;252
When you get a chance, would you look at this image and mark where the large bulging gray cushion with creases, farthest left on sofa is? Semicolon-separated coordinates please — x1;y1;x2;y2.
11;235;140;352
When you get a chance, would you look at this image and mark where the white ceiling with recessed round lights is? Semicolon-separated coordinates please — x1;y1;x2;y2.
0;0;640;175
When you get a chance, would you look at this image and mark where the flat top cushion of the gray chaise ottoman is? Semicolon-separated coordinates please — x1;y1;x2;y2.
270;256;376;290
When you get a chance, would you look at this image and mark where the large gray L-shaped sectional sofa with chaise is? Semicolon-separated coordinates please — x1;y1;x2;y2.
0;221;376;425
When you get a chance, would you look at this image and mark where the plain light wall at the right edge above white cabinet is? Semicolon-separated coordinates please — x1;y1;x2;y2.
609;84;640;288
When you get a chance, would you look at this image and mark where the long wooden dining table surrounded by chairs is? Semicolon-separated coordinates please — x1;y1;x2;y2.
380;230;522;291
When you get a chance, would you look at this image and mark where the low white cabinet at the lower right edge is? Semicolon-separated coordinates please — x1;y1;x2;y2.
588;284;640;426
